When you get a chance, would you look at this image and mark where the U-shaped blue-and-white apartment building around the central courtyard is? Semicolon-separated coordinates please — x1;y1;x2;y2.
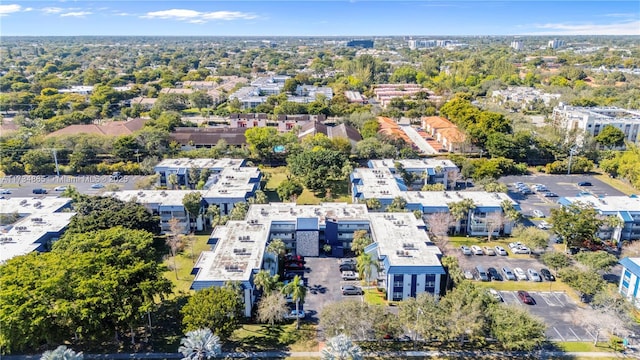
191;203;444;316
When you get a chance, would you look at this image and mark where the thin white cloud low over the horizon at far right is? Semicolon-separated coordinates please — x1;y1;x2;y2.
534;20;640;35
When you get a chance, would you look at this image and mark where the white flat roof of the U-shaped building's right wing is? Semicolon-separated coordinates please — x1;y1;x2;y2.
369;212;442;266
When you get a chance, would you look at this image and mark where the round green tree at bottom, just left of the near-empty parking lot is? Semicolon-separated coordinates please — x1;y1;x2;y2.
490;305;546;351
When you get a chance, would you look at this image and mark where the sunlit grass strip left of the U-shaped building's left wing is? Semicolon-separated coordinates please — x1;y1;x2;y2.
163;235;211;295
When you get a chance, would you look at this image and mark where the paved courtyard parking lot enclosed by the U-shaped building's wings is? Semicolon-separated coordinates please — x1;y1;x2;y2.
304;257;363;322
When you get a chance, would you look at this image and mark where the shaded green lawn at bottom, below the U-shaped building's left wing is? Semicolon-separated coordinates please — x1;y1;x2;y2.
228;321;318;352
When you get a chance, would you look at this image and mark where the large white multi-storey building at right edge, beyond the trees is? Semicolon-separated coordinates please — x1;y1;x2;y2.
552;103;640;144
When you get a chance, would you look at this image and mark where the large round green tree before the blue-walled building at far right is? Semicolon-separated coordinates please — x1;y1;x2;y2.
549;203;604;247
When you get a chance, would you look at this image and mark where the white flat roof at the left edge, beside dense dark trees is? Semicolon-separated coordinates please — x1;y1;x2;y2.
0;196;75;264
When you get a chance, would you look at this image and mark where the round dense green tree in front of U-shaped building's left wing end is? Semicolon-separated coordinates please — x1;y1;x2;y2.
181;287;243;339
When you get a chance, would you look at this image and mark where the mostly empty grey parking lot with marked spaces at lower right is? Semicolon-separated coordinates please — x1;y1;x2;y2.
499;291;595;341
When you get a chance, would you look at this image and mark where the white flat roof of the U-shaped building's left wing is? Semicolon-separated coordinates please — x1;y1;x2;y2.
194;221;271;282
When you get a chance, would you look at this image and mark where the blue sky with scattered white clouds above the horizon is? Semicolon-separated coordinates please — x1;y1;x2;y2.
0;0;640;36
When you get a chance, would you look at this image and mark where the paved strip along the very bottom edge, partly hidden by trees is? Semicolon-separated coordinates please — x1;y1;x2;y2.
0;351;638;360
